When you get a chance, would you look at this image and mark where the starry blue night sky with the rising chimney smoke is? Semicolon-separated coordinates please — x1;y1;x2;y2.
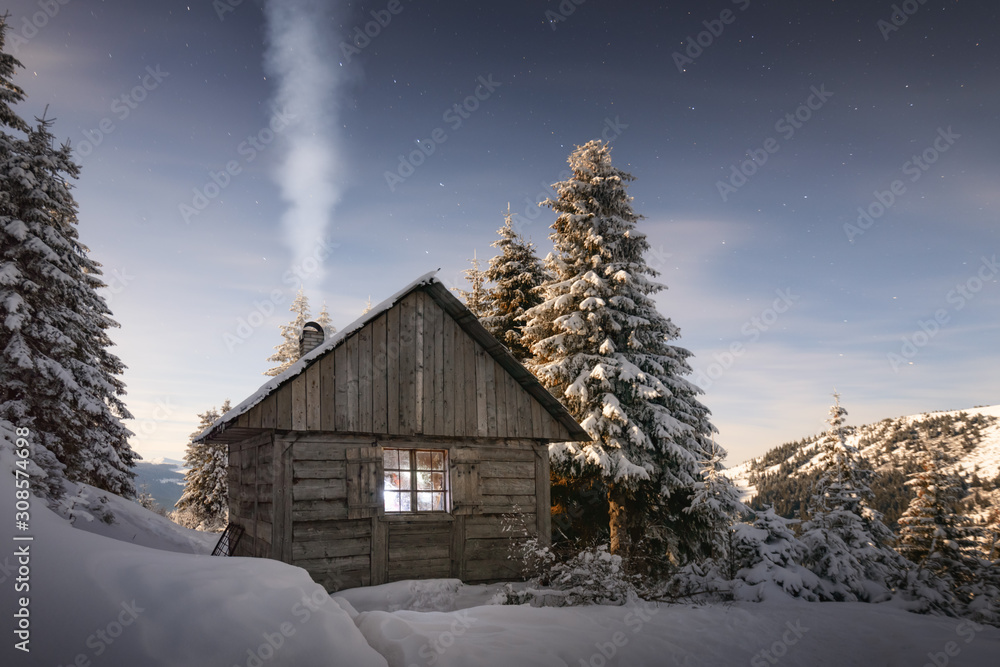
7;0;1000;463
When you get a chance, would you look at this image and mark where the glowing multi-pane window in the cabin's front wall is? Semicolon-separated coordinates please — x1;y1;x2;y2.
382;449;449;512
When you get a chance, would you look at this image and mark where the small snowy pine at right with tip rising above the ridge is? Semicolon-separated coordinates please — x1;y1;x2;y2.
801;393;904;602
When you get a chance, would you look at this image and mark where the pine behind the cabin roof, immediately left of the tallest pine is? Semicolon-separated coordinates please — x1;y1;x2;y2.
480;206;545;362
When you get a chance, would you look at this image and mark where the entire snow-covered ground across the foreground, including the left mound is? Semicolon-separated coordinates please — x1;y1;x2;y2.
0;451;1000;667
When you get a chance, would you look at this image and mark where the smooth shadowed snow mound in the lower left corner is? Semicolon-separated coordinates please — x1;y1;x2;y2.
0;434;386;667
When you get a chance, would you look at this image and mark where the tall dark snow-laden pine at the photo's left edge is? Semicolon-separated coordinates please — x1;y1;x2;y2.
0;21;139;499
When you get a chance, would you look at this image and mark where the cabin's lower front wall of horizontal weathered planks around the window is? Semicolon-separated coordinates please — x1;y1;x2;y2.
275;433;549;591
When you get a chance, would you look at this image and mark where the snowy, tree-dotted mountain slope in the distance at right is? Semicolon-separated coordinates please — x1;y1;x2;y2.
727;405;1000;530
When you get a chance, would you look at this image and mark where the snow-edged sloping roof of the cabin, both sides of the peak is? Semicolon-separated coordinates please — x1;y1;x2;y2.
194;271;590;442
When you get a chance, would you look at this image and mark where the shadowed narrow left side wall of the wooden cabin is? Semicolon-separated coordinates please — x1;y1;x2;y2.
229;433;274;558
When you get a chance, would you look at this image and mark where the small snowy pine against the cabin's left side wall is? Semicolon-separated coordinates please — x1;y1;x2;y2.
174;399;232;530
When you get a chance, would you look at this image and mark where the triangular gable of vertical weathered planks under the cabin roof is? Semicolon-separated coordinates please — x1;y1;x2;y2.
236;290;572;440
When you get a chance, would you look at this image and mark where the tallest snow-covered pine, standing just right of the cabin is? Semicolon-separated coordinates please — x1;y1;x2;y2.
523;141;715;558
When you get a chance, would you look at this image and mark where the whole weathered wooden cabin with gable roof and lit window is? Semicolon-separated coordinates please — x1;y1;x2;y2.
198;273;590;591
